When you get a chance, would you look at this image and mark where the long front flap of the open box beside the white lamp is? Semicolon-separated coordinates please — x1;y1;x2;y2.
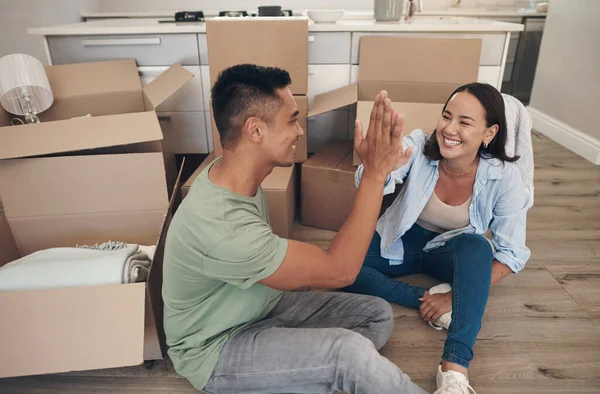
0;111;163;159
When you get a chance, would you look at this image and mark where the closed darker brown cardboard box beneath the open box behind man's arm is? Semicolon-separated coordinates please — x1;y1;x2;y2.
301;140;357;231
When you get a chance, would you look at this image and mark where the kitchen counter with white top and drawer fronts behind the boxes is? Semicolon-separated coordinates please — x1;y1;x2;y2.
28;12;523;154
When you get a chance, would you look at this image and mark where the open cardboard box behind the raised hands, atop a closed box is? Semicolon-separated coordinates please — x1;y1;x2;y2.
308;36;481;166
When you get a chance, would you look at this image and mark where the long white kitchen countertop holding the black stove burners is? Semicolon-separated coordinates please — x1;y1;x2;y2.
27;16;523;36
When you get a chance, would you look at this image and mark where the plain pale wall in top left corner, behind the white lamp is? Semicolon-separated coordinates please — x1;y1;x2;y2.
0;0;97;64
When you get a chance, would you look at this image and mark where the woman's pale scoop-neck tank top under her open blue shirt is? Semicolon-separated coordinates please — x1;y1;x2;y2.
417;191;473;233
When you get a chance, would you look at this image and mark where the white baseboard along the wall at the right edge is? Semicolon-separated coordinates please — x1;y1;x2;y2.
527;107;600;165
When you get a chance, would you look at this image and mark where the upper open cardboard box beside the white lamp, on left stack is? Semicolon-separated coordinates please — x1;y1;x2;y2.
0;59;193;191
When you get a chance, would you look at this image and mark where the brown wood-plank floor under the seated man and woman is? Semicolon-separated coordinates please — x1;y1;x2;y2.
0;135;600;394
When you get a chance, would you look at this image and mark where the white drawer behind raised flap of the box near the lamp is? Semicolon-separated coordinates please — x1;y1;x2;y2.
138;66;205;112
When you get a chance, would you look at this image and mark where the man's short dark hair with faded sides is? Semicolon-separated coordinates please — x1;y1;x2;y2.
211;64;291;148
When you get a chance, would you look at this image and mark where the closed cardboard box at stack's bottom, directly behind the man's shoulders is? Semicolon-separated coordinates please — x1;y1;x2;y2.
181;152;296;238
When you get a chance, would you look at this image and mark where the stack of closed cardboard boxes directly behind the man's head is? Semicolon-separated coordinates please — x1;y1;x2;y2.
183;18;308;238
